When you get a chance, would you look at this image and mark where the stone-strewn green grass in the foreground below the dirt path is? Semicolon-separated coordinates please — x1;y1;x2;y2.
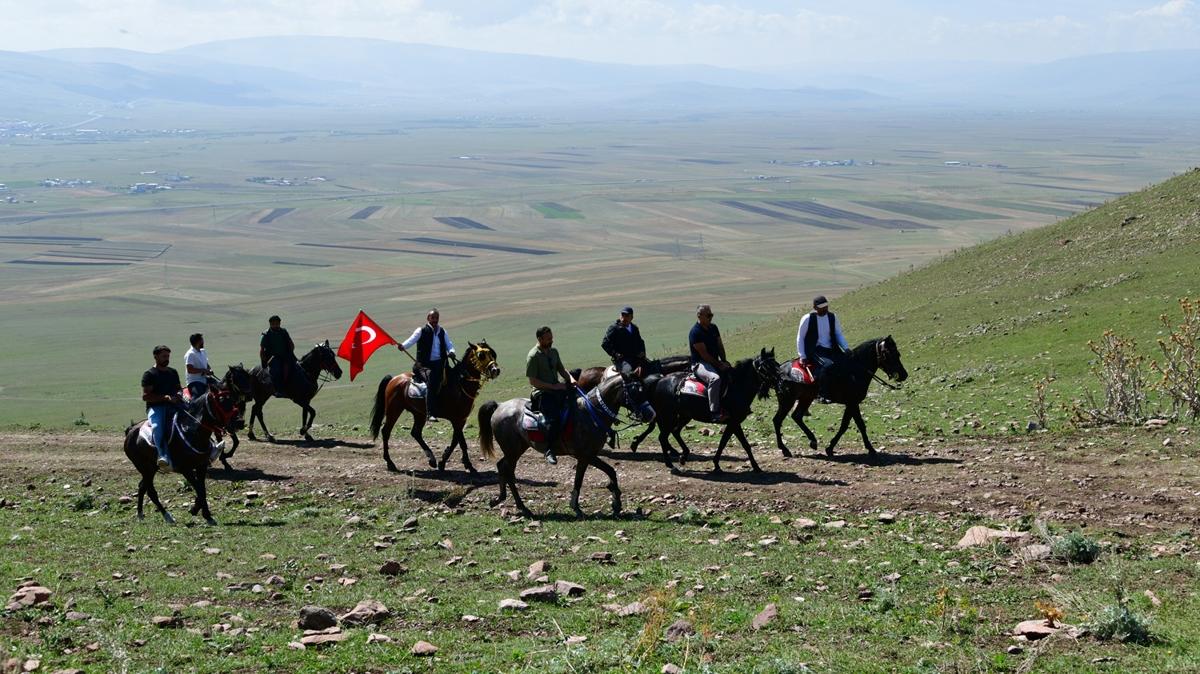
0;471;1200;673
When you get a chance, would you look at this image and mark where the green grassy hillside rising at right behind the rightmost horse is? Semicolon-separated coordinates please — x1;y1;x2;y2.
730;169;1200;438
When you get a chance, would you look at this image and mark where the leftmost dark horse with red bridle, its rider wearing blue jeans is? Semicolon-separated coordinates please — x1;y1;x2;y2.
125;385;238;524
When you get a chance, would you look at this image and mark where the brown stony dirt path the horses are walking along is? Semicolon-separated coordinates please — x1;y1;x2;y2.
0;432;1200;532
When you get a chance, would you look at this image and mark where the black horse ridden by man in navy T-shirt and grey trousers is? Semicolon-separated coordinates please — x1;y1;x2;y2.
647;349;779;475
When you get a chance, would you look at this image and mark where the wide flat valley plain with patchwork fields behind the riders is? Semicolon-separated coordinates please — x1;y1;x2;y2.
0;107;1194;433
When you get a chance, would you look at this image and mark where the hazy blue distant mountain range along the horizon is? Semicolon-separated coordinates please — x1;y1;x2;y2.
0;36;1200;116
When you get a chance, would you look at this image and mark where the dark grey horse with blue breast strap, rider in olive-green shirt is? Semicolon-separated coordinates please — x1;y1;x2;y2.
479;373;654;518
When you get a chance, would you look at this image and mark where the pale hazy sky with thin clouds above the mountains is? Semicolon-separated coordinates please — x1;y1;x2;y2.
0;0;1200;67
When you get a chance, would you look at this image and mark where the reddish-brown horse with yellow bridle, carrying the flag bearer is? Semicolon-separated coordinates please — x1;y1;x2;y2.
371;339;500;473
